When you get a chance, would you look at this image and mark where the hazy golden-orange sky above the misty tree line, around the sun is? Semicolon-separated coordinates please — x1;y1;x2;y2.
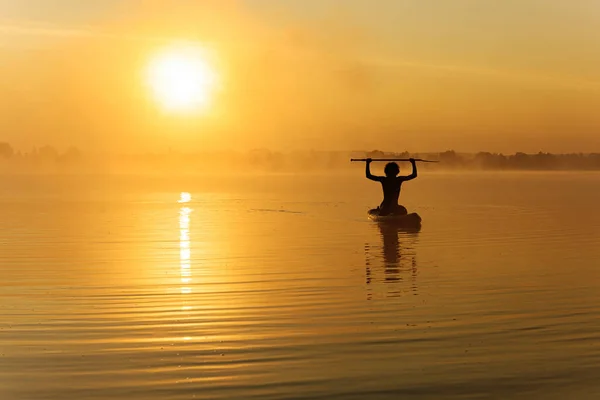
0;0;600;153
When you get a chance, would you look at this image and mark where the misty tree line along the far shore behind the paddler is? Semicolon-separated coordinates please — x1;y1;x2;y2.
0;142;600;172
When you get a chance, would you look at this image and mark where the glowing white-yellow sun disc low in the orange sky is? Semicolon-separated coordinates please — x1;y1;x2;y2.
147;45;217;112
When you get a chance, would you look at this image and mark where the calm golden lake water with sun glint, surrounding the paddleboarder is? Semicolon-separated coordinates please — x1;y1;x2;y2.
0;171;600;400
